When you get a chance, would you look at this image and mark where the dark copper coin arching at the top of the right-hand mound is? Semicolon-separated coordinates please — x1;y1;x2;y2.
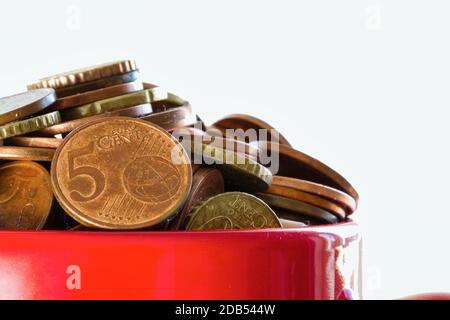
212;114;291;147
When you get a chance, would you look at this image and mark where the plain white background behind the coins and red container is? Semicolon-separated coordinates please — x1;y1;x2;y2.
0;0;450;298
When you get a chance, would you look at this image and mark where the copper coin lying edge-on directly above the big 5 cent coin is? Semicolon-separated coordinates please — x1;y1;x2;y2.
37;103;153;136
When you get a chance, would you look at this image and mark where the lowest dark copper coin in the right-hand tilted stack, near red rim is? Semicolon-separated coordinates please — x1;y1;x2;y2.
255;193;339;223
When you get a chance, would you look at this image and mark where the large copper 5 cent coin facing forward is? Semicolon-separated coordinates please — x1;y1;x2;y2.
51;117;192;230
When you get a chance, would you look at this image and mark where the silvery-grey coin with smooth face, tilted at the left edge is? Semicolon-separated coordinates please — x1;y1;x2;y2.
0;89;56;124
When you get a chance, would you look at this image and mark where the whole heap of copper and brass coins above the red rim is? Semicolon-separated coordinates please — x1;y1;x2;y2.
0;60;358;231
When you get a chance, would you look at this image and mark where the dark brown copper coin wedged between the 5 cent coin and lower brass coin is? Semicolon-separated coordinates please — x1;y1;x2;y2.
170;167;225;230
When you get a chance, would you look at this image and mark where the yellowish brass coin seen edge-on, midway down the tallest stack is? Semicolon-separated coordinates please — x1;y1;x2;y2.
61;88;167;121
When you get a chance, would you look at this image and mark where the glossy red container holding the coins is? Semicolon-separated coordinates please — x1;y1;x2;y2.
0;221;361;300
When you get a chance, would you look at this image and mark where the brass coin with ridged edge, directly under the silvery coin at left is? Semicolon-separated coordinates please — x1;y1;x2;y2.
0;111;61;139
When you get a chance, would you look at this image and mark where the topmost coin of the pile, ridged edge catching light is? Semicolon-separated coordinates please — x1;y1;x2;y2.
28;60;137;90
